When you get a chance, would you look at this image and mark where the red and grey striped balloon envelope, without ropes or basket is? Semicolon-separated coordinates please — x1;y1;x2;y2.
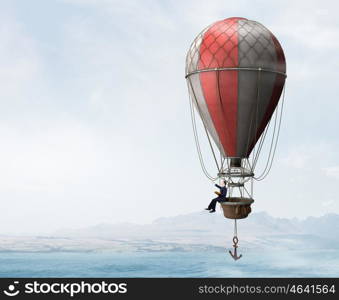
186;18;286;158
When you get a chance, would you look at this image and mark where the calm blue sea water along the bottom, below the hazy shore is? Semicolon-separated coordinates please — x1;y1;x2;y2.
0;249;339;277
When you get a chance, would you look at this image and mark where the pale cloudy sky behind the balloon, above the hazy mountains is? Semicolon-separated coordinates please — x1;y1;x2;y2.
0;0;339;234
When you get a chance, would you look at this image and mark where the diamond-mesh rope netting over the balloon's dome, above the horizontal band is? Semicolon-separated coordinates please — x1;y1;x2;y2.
186;19;275;75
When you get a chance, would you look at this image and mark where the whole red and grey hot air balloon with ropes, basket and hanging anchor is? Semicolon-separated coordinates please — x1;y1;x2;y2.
185;17;286;259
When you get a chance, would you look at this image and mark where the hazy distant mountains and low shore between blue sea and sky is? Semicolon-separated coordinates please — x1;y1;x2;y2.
0;211;339;252
